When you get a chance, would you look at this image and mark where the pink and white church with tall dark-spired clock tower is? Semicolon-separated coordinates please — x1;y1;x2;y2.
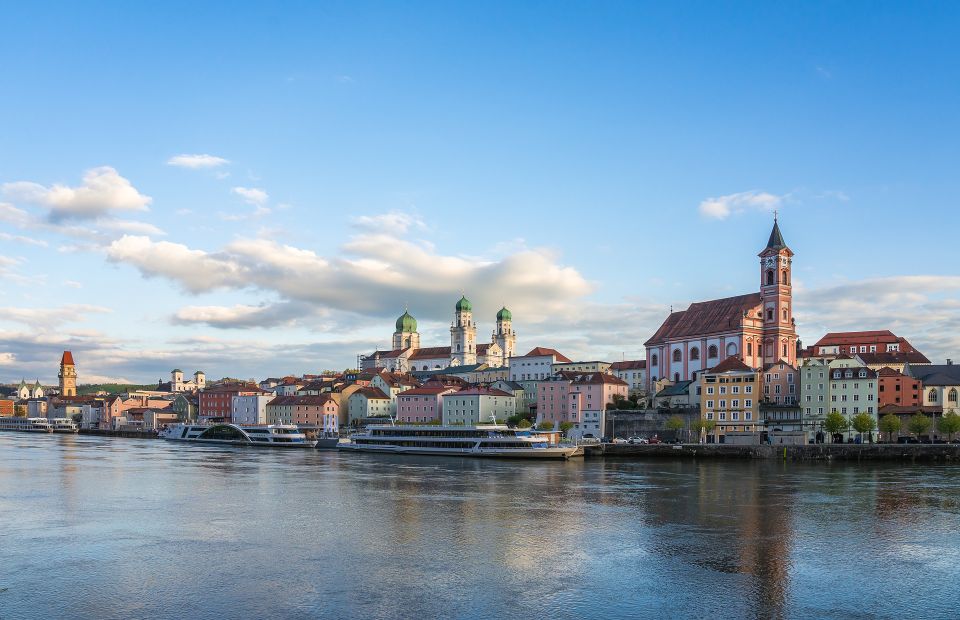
644;217;797;389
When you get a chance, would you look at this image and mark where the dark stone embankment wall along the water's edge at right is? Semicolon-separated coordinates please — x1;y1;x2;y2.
600;444;960;463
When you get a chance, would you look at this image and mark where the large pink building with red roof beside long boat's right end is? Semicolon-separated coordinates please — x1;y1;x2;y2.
537;372;630;438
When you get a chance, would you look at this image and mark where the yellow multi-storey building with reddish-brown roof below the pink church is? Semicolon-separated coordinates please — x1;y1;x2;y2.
700;357;762;442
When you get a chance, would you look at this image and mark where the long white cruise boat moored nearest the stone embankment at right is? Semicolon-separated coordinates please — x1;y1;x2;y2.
337;424;583;459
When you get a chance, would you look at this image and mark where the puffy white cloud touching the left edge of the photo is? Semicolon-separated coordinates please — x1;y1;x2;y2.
0;166;152;221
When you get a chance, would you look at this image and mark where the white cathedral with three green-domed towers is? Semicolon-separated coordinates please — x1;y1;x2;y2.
360;297;517;372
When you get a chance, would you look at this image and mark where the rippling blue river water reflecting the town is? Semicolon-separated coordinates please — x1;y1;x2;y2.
0;433;960;620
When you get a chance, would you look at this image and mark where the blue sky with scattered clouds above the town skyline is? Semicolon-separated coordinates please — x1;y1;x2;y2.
0;2;960;381
